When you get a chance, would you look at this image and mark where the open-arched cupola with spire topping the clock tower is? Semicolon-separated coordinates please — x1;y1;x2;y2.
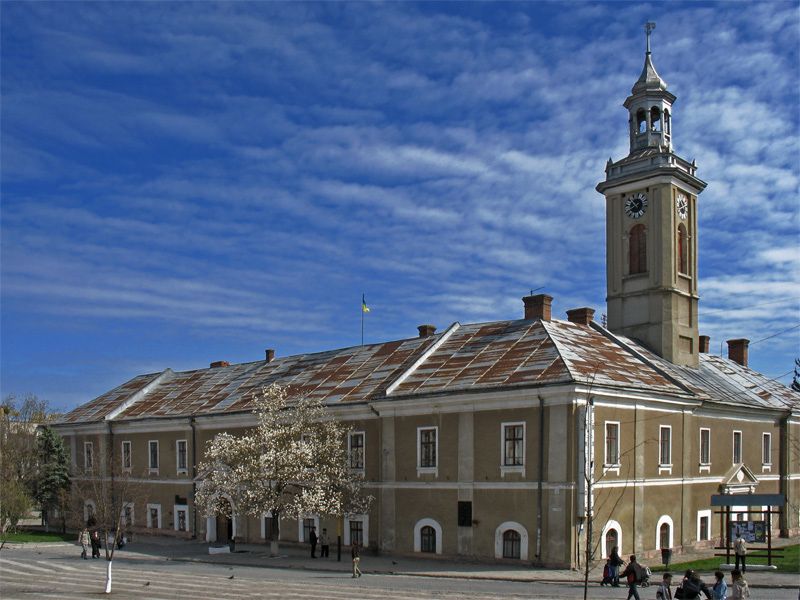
624;23;675;154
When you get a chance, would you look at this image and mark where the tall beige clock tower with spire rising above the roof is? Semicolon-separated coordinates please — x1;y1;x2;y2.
597;23;706;367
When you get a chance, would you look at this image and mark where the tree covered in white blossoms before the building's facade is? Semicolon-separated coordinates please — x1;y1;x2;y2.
195;384;372;555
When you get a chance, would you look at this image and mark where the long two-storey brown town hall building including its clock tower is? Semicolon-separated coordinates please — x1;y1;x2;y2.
55;32;800;567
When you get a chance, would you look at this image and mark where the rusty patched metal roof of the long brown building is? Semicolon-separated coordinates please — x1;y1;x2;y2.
57;320;800;423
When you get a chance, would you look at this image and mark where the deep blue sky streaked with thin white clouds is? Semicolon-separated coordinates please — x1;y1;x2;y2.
0;2;800;409
